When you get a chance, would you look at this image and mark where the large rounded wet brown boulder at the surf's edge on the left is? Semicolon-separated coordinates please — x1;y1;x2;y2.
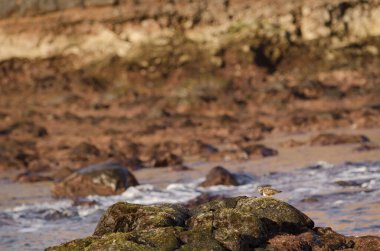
52;162;138;198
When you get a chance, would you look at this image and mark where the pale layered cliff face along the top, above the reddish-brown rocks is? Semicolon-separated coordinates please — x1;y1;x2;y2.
0;0;380;73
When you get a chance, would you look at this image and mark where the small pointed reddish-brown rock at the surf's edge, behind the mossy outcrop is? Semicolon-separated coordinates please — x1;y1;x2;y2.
199;166;239;187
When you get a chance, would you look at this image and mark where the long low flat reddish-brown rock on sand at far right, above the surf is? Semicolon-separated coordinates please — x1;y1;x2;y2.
310;133;369;146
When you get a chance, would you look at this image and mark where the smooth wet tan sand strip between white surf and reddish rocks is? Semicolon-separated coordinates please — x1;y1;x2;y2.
0;128;380;210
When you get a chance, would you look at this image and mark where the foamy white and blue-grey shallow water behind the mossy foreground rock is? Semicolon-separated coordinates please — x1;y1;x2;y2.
0;162;380;250
